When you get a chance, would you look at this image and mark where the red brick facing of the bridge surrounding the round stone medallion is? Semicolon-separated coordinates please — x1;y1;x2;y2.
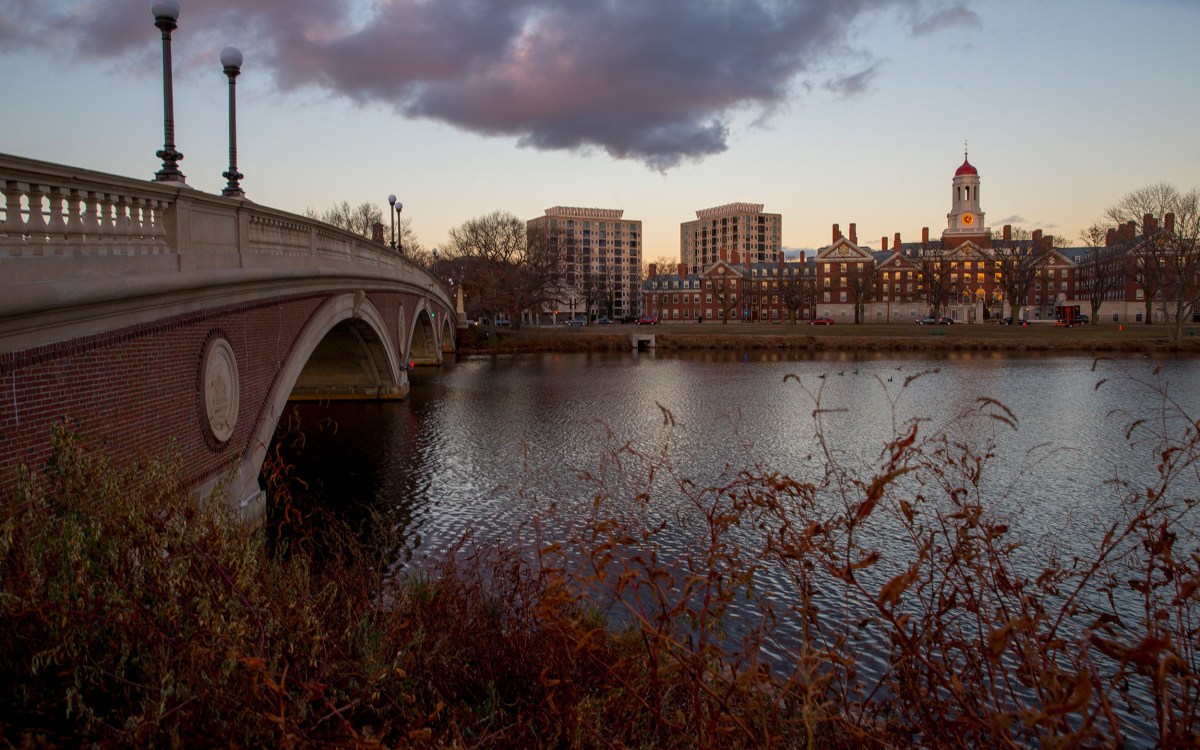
0;293;415;497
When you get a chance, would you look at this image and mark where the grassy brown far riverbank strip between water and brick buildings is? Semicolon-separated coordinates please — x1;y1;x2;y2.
458;323;1200;355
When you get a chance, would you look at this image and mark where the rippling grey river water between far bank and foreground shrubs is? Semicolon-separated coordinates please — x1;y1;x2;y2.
272;352;1200;744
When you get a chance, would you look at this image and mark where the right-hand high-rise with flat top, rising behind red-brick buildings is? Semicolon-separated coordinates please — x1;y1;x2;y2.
679;203;784;274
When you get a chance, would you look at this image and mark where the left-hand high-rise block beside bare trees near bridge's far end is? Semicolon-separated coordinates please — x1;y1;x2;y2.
526;206;642;320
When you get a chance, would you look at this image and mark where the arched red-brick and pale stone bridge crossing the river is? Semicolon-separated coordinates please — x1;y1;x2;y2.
0;154;457;517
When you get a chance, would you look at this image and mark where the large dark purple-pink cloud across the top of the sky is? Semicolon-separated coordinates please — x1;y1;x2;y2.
11;0;979;170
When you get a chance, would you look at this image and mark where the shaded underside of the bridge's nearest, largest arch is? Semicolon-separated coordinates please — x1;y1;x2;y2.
288;318;408;401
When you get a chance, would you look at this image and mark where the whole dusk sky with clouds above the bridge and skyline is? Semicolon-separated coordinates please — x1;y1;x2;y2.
0;0;1200;262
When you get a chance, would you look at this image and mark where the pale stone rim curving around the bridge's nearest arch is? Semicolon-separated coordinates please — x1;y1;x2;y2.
199;293;408;520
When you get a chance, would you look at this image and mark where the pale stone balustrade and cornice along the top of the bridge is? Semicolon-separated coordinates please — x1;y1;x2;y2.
0;154;454;352
